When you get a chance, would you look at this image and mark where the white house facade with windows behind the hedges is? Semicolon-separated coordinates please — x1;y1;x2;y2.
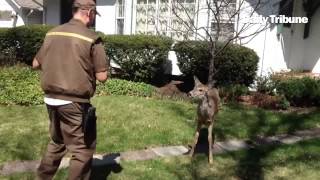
5;0;320;74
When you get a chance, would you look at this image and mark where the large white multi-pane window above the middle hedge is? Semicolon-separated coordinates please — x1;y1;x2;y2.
136;0;196;40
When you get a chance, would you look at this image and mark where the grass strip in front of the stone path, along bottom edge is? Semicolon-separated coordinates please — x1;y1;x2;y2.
0;139;320;180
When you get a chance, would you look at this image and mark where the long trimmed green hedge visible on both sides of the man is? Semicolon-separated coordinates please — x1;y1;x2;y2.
0;25;172;84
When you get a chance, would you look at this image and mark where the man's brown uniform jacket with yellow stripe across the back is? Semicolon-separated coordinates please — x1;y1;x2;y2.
36;19;109;102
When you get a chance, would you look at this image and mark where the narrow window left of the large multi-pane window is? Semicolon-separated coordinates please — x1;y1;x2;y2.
116;0;125;34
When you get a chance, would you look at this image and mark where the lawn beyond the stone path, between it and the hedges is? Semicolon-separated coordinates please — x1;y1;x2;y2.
0;96;320;165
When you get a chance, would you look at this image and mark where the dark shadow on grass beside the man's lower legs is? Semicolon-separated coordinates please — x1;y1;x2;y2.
90;153;123;180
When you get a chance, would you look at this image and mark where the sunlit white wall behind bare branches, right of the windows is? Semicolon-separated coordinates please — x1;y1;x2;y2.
236;0;288;75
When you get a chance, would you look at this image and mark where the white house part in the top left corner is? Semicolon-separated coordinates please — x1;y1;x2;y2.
0;0;44;28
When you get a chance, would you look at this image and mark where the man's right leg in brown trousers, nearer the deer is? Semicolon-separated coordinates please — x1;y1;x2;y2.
59;103;96;180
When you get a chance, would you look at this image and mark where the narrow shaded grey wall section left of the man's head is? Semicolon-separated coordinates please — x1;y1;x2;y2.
44;0;61;25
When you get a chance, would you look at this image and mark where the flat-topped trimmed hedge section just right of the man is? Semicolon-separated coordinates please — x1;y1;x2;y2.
103;35;172;84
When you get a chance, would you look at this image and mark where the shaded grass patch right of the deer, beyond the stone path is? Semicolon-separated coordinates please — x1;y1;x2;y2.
214;104;320;141
